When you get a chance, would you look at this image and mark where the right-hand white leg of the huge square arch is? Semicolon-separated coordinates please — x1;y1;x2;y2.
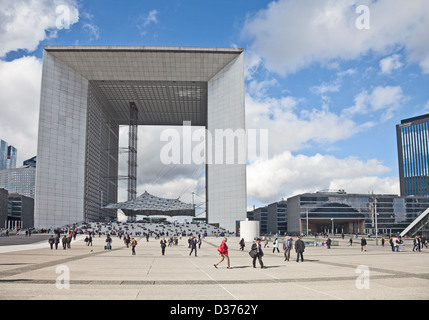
206;54;247;232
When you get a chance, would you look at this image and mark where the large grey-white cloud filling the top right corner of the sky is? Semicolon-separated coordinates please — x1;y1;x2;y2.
243;0;429;75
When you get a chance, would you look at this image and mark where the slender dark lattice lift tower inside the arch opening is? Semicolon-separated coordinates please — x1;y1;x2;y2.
128;102;138;219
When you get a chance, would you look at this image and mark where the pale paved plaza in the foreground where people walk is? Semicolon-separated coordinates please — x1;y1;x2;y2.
0;235;429;301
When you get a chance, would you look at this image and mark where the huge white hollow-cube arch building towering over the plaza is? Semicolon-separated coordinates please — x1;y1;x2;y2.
35;46;246;231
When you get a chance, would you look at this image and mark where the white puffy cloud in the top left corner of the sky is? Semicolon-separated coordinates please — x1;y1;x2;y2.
0;0;79;57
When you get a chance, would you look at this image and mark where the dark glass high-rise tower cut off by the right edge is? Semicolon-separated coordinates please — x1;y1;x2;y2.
396;114;429;196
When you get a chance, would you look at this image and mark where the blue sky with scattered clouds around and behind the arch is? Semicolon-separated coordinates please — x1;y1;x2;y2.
0;0;429;212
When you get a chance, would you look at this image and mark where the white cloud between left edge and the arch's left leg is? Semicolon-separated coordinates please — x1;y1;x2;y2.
0;57;42;166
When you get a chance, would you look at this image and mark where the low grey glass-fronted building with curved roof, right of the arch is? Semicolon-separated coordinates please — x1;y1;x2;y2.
248;191;429;234
